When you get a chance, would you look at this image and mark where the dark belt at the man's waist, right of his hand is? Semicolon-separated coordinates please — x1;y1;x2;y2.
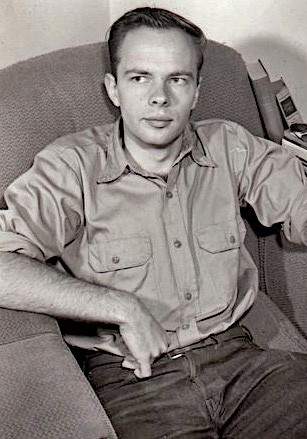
166;324;253;360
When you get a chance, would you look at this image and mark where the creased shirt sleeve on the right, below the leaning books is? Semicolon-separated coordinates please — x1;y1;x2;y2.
236;126;307;245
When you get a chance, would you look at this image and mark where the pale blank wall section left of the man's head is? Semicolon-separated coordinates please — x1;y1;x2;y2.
0;0;110;68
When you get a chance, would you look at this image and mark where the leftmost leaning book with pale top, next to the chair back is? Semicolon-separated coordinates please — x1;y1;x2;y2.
246;60;284;143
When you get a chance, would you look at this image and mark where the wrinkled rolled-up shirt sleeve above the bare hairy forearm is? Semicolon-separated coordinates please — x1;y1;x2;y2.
0;148;83;260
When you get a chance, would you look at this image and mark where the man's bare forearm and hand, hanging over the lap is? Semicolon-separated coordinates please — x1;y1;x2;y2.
0;252;168;378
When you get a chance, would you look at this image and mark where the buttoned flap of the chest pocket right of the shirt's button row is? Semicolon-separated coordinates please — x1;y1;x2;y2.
197;220;240;253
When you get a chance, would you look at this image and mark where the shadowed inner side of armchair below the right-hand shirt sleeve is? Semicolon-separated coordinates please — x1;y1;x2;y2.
242;208;307;353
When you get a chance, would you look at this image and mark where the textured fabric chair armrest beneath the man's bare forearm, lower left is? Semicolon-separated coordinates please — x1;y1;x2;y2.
0;308;116;439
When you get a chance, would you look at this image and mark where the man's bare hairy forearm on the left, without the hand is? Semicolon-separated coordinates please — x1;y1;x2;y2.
0;253;139;325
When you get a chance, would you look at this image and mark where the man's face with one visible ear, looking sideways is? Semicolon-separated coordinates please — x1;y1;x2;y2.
105;27;202;152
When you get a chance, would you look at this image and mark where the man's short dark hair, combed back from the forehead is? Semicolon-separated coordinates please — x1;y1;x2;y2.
107;7;207;78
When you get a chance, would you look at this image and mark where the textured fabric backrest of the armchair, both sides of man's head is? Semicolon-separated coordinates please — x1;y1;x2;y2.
0;41;262;207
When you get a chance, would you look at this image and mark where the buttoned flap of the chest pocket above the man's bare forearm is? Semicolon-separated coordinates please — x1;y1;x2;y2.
89;237;152;273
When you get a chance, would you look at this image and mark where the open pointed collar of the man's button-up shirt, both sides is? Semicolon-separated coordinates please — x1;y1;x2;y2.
97;118;217;183
